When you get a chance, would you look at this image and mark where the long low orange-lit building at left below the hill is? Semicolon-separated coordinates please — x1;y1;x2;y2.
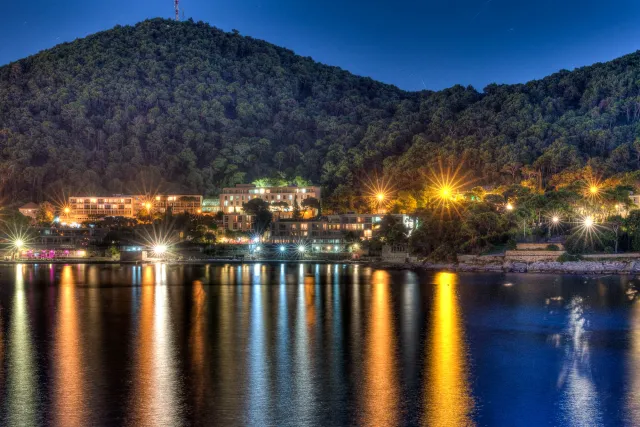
68;194;202;222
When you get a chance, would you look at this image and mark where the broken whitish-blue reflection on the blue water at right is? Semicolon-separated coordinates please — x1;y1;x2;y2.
558;297;602;426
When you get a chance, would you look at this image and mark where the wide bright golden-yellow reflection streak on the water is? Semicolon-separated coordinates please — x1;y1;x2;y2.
423;273;474;426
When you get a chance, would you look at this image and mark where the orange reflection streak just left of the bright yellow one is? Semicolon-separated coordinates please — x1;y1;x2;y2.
365;270;398;426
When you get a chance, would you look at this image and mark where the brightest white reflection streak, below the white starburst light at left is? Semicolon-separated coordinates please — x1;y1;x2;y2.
152;264;179;426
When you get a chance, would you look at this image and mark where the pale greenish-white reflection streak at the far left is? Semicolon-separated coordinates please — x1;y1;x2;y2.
7;264;37;426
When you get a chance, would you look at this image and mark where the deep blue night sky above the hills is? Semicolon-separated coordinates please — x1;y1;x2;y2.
0;0;640;90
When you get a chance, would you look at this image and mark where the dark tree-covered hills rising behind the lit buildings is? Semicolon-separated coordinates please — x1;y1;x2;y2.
0;19;640;201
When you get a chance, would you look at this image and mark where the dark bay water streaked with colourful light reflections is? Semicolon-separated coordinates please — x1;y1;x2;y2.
0;263;640;426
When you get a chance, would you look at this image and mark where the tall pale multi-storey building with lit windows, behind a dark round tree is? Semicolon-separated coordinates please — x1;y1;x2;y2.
220;184;321;217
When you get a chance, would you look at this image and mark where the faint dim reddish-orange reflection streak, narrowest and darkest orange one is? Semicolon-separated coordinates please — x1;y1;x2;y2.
190;280;208;410
